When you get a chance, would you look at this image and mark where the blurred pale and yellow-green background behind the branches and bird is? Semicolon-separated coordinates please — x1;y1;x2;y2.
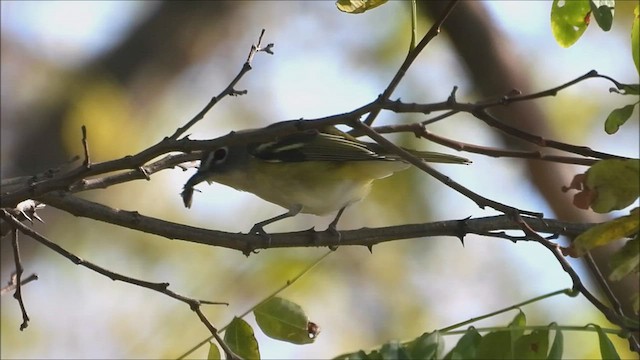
0;1;639;358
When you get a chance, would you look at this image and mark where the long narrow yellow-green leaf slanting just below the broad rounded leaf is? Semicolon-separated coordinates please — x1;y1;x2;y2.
570;211;640;257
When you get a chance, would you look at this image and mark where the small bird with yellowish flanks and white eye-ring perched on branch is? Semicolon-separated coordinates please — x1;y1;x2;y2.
181;127;470;235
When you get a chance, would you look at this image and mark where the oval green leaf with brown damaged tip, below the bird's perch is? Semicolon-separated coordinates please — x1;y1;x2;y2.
253;296;315;344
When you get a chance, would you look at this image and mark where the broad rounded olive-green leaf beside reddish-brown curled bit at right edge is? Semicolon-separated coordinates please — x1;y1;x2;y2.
585;159;640;214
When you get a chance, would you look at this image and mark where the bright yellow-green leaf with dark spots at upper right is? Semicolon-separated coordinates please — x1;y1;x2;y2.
551;0;591;47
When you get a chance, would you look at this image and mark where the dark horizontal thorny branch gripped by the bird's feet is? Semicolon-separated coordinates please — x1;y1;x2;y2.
36;192;594;253
